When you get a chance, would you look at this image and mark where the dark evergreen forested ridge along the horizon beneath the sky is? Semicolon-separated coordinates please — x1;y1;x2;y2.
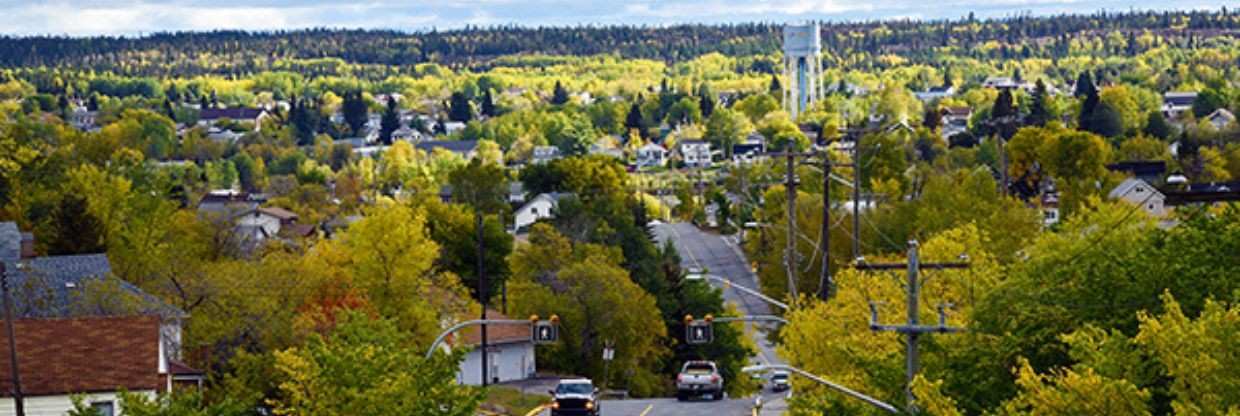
0;9;1240;76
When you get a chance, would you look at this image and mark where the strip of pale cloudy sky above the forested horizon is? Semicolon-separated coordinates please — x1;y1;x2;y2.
0;0;1225;36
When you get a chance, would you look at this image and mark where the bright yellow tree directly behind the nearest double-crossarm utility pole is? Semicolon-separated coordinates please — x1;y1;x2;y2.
780;225;1001;414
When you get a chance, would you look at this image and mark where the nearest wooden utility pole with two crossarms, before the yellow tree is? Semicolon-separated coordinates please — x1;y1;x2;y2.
857;240;968;414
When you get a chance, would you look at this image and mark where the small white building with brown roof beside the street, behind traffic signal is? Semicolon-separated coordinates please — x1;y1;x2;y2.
453;310;538;386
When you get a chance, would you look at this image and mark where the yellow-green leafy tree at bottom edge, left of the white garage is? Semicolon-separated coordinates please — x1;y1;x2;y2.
273;313;482;416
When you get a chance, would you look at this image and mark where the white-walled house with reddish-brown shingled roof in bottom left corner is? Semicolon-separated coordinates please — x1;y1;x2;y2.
0;315;205;416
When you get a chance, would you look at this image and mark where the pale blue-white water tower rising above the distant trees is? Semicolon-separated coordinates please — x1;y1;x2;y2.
784;24;822;119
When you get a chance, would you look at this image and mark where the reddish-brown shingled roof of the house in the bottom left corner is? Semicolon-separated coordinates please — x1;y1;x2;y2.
0;315;160;397
